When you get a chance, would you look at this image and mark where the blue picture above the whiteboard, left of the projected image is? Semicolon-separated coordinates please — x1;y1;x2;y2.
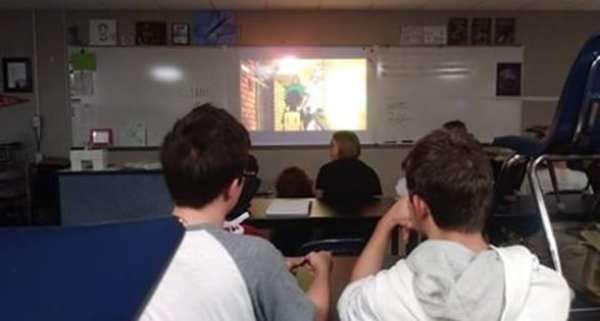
193;10;237;46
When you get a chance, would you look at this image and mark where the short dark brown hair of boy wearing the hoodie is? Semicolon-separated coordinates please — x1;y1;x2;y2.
406;129;494;233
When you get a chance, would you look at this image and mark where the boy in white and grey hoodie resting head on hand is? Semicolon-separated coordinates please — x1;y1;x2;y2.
338;130;570;320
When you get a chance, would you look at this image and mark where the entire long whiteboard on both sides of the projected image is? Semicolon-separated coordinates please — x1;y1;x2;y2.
69;47;523;147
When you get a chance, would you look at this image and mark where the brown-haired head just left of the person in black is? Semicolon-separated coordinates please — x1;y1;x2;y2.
275;166;315;198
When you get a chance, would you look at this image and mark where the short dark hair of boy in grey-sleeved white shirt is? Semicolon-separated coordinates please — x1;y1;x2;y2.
160;104;250;208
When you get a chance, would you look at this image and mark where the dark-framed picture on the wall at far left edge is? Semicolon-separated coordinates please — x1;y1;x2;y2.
2;58;33;93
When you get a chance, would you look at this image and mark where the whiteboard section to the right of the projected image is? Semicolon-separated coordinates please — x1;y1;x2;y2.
374;47;523;143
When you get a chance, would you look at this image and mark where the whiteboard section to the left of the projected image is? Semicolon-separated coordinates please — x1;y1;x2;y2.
70;47;239;146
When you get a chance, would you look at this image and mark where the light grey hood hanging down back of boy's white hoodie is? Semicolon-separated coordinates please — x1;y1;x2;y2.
407;240;505;320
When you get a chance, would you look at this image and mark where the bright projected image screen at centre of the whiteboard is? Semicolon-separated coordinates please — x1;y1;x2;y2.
239;48;371;144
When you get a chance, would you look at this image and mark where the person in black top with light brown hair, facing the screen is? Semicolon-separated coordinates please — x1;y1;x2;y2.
316;131;381;202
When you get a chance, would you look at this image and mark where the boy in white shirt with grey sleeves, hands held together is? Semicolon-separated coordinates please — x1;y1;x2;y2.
140;104;331;321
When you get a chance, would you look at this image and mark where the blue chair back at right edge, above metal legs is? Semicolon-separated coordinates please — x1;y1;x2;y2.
540;34;600;154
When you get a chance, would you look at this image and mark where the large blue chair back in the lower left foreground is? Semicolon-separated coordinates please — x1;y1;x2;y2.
0;217;184;321
